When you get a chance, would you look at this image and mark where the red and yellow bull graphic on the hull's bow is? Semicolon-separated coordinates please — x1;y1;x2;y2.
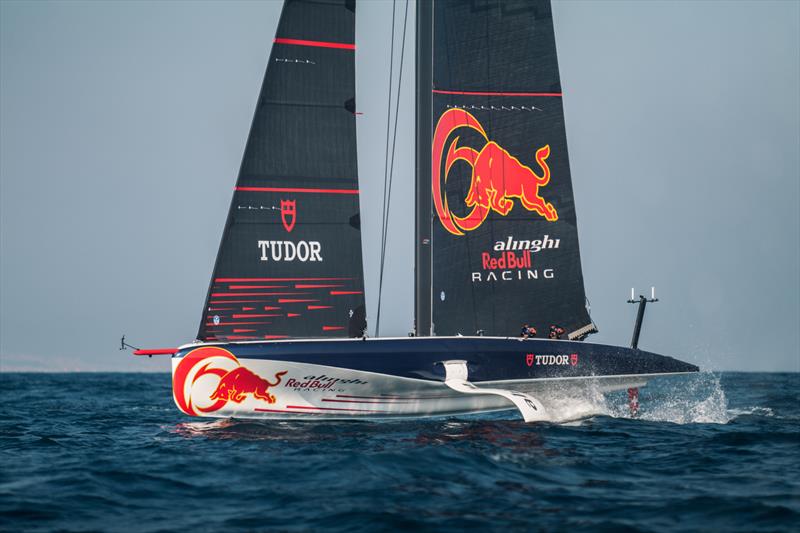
172;346;286;416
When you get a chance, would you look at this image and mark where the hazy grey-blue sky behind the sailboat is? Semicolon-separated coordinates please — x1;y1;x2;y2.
0;0;800;371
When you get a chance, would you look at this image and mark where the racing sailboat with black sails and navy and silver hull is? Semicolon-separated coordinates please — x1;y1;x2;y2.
135;0;698;421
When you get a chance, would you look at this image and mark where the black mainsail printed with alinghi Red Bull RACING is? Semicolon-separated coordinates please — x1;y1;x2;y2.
430;0;595;338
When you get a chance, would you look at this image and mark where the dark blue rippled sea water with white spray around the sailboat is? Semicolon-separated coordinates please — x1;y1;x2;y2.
0;373;800;532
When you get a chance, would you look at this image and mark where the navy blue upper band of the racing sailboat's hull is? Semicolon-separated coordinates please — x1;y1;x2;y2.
175;337;699;382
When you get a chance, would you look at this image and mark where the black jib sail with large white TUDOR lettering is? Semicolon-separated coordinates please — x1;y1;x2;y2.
198;0;366;341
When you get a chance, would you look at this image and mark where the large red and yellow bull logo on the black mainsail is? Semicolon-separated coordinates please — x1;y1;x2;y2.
431;108;558;235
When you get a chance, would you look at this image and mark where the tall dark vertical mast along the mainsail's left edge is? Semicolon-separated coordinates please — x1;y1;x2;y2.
414;0;433;337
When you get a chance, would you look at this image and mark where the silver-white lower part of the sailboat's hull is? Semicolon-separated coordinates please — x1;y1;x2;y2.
173;358;680;420
